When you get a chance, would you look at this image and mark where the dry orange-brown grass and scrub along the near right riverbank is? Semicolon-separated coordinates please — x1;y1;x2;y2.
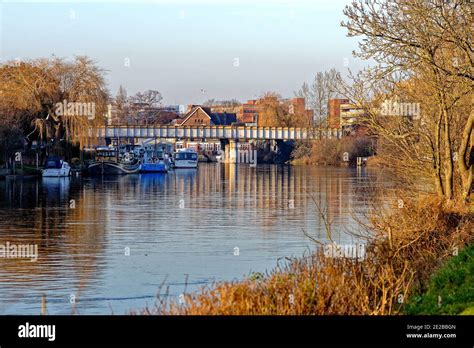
141;199;474;315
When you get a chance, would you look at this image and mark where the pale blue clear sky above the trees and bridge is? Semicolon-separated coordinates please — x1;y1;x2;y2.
0;0;364;105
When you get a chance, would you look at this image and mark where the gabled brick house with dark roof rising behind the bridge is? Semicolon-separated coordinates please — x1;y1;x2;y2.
178;105;237;126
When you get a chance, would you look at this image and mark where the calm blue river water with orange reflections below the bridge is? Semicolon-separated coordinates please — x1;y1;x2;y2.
0;164;386;314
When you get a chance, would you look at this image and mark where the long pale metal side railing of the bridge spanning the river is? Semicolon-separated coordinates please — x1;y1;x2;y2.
97;126;342;140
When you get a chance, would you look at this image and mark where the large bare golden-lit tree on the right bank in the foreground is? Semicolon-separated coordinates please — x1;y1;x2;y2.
342;0;474;203
